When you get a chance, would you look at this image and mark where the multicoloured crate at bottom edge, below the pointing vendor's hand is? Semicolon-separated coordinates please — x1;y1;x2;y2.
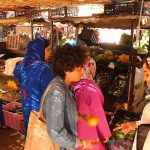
107;139;132;150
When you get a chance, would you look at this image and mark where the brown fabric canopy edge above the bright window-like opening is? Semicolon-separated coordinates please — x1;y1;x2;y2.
51;15;139;29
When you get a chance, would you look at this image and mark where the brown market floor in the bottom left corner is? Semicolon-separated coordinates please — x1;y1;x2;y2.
0;128;24;150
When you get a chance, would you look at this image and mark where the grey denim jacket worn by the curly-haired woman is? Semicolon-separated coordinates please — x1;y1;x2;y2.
42;76;77;150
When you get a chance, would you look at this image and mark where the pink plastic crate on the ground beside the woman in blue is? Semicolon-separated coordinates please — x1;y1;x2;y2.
3;102;23;132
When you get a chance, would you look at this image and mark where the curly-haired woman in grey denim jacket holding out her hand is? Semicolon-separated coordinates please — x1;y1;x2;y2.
42;44;97;150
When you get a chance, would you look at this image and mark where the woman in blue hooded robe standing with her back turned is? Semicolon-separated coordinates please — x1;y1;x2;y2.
14;38;54;137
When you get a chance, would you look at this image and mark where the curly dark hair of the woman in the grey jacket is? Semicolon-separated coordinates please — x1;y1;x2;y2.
52;43;88;79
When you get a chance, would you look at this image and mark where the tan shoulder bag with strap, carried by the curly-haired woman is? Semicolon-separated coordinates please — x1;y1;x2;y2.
24;83;60;150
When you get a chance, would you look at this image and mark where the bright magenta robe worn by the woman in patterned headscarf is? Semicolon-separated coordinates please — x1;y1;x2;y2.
73;79;111;150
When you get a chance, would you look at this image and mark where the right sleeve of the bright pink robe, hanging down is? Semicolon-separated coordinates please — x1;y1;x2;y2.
90;92;111;139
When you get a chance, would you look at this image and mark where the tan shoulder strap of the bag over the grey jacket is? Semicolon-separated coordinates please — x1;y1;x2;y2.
38;82;63;122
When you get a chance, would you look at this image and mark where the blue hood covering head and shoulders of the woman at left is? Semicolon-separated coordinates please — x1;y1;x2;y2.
14;38;48;91
